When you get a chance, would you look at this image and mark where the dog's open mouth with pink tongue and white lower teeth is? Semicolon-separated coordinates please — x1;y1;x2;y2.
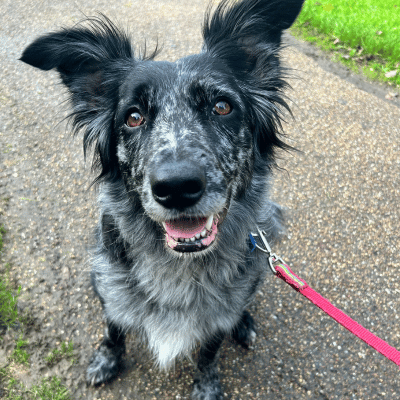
163;214;218;253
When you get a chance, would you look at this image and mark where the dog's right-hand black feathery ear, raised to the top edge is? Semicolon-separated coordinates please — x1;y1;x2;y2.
203;0;304;156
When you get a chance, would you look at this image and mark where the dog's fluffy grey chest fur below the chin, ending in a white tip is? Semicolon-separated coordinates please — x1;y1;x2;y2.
99;256;245;368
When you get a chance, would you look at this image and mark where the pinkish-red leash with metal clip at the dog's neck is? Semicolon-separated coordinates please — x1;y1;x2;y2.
250;227;400;366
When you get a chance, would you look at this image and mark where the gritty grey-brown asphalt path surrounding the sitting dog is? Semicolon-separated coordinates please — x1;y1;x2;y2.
0;0;400;400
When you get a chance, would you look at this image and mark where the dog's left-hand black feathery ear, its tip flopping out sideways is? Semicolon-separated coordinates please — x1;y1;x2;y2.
20;16;135;182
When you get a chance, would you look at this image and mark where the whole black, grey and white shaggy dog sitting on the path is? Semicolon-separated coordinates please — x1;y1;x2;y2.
21;0;303;399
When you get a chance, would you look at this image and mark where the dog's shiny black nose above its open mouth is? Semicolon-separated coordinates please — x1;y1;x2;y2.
150;162;206;210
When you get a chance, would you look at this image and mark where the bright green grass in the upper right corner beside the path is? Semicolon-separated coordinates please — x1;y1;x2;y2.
292;0;400;85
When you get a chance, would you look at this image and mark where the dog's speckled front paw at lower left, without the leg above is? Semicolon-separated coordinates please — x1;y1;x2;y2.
86;344;123;386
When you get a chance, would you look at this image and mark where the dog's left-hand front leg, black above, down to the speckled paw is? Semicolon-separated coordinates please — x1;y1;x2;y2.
86;323;125;385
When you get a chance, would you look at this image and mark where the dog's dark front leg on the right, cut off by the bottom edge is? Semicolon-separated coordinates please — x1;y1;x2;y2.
192;334;224;400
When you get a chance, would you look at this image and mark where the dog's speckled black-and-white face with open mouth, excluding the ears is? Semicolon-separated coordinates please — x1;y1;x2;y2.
114;54;254;252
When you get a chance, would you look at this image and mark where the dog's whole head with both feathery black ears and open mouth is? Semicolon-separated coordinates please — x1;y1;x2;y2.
21;0;303;253
